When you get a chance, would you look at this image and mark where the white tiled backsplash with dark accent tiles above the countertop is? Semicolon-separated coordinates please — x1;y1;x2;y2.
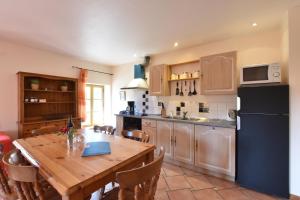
119;90;236;120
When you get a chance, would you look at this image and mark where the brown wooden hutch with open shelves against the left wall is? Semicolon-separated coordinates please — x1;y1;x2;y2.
17;72;81;138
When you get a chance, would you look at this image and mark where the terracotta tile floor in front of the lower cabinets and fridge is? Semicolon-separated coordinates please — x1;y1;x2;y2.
155;163;284;200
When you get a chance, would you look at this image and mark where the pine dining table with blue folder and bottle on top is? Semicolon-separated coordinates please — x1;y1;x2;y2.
13;129;155;200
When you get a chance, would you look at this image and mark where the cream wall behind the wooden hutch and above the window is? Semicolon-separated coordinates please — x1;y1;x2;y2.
0;40;112;138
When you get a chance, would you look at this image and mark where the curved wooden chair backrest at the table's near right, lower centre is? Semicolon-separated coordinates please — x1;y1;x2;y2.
116;147;165;200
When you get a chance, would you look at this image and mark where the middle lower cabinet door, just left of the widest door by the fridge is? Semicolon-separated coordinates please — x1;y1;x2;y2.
174;123;194;164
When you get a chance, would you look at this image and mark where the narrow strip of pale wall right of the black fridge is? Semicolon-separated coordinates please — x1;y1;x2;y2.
289;6;300;196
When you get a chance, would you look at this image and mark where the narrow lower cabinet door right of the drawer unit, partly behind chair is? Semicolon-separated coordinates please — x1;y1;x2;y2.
157;121;173;159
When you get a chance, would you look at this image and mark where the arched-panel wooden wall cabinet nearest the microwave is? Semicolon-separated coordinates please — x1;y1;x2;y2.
201;52;236;95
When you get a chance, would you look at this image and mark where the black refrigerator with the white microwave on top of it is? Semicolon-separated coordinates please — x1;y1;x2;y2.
236;85;289;198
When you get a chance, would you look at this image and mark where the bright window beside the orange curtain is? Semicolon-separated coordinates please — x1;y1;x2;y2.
83;84;104;126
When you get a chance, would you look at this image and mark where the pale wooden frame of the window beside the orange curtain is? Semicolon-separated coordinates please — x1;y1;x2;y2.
83;83;105;127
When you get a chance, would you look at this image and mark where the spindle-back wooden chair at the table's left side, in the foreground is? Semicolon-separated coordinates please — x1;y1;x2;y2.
3;150;61;200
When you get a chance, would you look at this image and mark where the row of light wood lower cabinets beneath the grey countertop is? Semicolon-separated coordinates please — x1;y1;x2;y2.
117;116;236;180
